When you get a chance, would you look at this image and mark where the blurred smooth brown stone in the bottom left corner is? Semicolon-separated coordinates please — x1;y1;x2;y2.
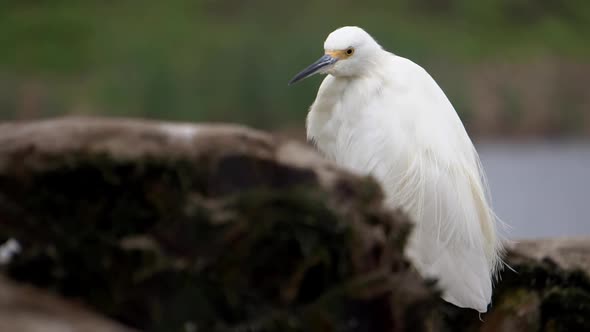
0;278;132;332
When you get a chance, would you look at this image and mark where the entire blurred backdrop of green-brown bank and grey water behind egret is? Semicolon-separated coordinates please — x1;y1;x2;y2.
0;0;590;238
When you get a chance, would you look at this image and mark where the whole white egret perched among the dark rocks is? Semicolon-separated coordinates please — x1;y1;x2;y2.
289;27;502;312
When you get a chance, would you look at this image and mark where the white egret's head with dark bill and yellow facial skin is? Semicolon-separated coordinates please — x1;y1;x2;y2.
289;27;381;84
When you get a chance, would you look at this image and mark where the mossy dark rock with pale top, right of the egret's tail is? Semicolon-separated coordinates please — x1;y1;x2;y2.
497;237;590;331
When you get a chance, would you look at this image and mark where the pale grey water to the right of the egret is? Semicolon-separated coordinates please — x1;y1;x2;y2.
477;141;590;239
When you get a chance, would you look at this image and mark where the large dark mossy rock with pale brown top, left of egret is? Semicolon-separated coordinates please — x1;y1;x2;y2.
0;119;439;331
